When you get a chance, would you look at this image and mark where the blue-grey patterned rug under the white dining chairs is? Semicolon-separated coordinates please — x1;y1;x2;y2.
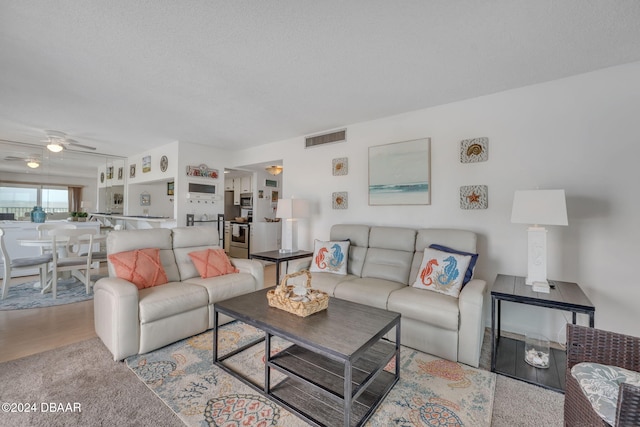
0;277;93;310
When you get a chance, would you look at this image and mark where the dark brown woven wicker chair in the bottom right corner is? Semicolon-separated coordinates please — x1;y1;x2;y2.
564;324;640;427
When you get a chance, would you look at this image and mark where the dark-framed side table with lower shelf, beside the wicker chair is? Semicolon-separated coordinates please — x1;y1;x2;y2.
491;274;596;393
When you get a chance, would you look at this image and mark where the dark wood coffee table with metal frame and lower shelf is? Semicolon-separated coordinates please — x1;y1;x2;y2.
213;289;400;427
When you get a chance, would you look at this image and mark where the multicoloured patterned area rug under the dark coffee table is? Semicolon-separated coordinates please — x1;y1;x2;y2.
126;322;496;427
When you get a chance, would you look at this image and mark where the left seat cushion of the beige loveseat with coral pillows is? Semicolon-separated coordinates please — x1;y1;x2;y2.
138;282;209;324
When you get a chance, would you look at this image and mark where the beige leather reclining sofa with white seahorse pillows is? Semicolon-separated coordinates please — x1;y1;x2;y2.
292;224;487;367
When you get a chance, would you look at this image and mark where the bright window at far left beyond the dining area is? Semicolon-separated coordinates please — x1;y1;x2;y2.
0;184;70;219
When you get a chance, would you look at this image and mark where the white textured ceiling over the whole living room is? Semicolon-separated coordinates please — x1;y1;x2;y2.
0;0;640;166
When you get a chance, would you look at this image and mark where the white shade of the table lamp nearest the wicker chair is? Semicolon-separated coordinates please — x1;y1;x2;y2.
511;190;569;225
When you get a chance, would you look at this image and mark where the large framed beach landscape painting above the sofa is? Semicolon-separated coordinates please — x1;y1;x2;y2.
369;138;431;206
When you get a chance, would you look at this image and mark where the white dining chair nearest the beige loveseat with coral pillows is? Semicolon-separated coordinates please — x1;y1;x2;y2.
49;228;96;299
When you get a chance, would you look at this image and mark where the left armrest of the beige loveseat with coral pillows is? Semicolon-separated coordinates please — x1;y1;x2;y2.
93;277;140;360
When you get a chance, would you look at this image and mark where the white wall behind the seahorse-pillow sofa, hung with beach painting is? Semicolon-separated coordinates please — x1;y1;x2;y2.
234;63;640;341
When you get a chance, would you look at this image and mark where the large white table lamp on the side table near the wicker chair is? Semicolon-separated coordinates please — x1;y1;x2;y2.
511;190;569;285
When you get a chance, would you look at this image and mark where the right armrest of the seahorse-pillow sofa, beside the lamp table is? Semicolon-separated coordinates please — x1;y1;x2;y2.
458;279;487;368
